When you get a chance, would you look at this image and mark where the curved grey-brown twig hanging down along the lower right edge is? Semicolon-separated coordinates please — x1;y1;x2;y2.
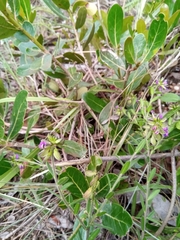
155;148;177;237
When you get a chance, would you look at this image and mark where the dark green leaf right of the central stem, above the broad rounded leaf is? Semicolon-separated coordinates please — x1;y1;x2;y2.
96;173;118;198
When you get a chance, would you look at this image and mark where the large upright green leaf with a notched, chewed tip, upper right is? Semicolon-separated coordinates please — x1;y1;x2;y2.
145;14;168;60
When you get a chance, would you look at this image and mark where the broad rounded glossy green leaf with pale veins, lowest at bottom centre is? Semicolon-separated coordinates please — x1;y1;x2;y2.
102;202;132;236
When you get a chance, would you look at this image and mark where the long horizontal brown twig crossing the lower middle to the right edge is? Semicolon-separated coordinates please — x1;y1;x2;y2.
55;151;180;167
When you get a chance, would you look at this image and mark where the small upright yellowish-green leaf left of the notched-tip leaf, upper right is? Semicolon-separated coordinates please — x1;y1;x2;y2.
124;37;135;64
